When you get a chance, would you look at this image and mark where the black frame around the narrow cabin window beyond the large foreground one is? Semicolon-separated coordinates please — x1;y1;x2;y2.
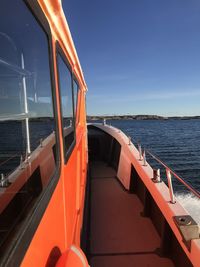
56;41;76;164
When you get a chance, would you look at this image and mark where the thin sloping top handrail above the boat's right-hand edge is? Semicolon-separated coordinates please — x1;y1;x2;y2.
146;150;200;198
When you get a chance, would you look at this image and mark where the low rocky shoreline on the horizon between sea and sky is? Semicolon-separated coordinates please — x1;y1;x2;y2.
87;115;200;121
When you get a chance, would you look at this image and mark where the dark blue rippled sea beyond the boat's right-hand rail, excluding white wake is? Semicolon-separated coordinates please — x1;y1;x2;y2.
107;120;200;191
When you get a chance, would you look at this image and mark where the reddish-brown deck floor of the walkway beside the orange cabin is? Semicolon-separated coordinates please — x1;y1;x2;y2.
90;162;174;267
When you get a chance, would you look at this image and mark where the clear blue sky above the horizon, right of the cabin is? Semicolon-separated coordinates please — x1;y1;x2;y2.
63;0;200;116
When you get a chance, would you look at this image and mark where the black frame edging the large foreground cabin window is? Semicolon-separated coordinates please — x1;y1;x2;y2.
1;0;61;266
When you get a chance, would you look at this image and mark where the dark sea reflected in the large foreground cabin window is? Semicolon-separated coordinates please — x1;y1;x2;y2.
0;120;55;176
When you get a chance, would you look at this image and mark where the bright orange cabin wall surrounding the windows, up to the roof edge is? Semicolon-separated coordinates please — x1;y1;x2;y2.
21;1;87;267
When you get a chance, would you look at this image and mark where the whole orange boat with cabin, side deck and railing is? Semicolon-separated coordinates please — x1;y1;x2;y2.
0;0;200;267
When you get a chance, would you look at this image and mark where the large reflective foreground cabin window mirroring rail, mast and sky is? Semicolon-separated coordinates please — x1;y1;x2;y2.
0;0;58;257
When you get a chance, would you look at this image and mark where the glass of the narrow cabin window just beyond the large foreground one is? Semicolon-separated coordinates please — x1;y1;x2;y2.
57;53;75;162
